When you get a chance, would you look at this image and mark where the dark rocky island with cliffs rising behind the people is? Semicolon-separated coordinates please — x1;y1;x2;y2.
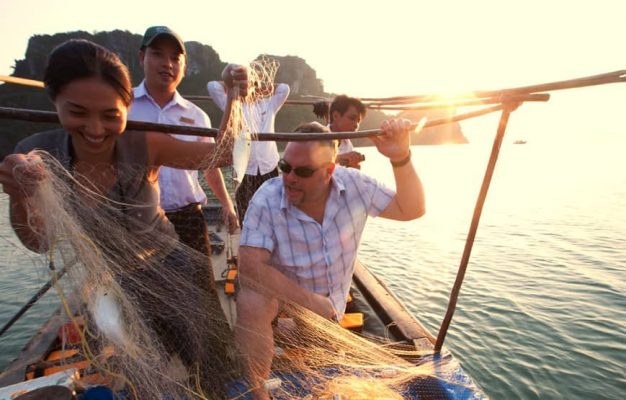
0;30;468;159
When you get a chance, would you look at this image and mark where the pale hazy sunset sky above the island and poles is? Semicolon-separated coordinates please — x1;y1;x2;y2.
0;0;626;142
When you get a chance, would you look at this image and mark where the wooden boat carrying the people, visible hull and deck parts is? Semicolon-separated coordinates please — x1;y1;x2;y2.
0;207;486;399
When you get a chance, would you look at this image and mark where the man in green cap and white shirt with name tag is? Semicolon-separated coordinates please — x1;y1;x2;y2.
128;26;238;262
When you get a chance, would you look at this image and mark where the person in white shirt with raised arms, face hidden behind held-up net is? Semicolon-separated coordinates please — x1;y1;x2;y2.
207;69;289;226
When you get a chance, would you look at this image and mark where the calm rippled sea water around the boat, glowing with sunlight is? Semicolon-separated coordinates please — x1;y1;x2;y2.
0;136;626;399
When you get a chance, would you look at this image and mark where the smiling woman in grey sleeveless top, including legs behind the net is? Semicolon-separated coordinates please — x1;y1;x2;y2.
0;40;247;396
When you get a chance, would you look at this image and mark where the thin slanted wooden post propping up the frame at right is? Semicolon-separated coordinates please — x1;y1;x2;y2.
435;103;517;353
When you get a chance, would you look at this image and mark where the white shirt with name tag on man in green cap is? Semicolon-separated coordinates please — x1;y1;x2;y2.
128;81;214;211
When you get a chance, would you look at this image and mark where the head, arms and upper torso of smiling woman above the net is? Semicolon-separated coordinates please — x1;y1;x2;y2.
0;40;247;251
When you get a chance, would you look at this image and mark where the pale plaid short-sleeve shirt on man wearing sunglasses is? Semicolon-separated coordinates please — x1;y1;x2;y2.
240;166;395;317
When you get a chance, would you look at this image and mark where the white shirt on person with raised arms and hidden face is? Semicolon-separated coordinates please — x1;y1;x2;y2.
207;81;289;175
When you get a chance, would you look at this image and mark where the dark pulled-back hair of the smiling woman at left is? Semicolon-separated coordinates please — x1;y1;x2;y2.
43;39;133;106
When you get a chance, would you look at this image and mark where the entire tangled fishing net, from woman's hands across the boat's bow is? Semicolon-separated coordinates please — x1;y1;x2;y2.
0;57;478;399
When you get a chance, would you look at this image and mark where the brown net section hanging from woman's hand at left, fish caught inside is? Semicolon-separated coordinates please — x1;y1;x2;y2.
8;153;235;398
